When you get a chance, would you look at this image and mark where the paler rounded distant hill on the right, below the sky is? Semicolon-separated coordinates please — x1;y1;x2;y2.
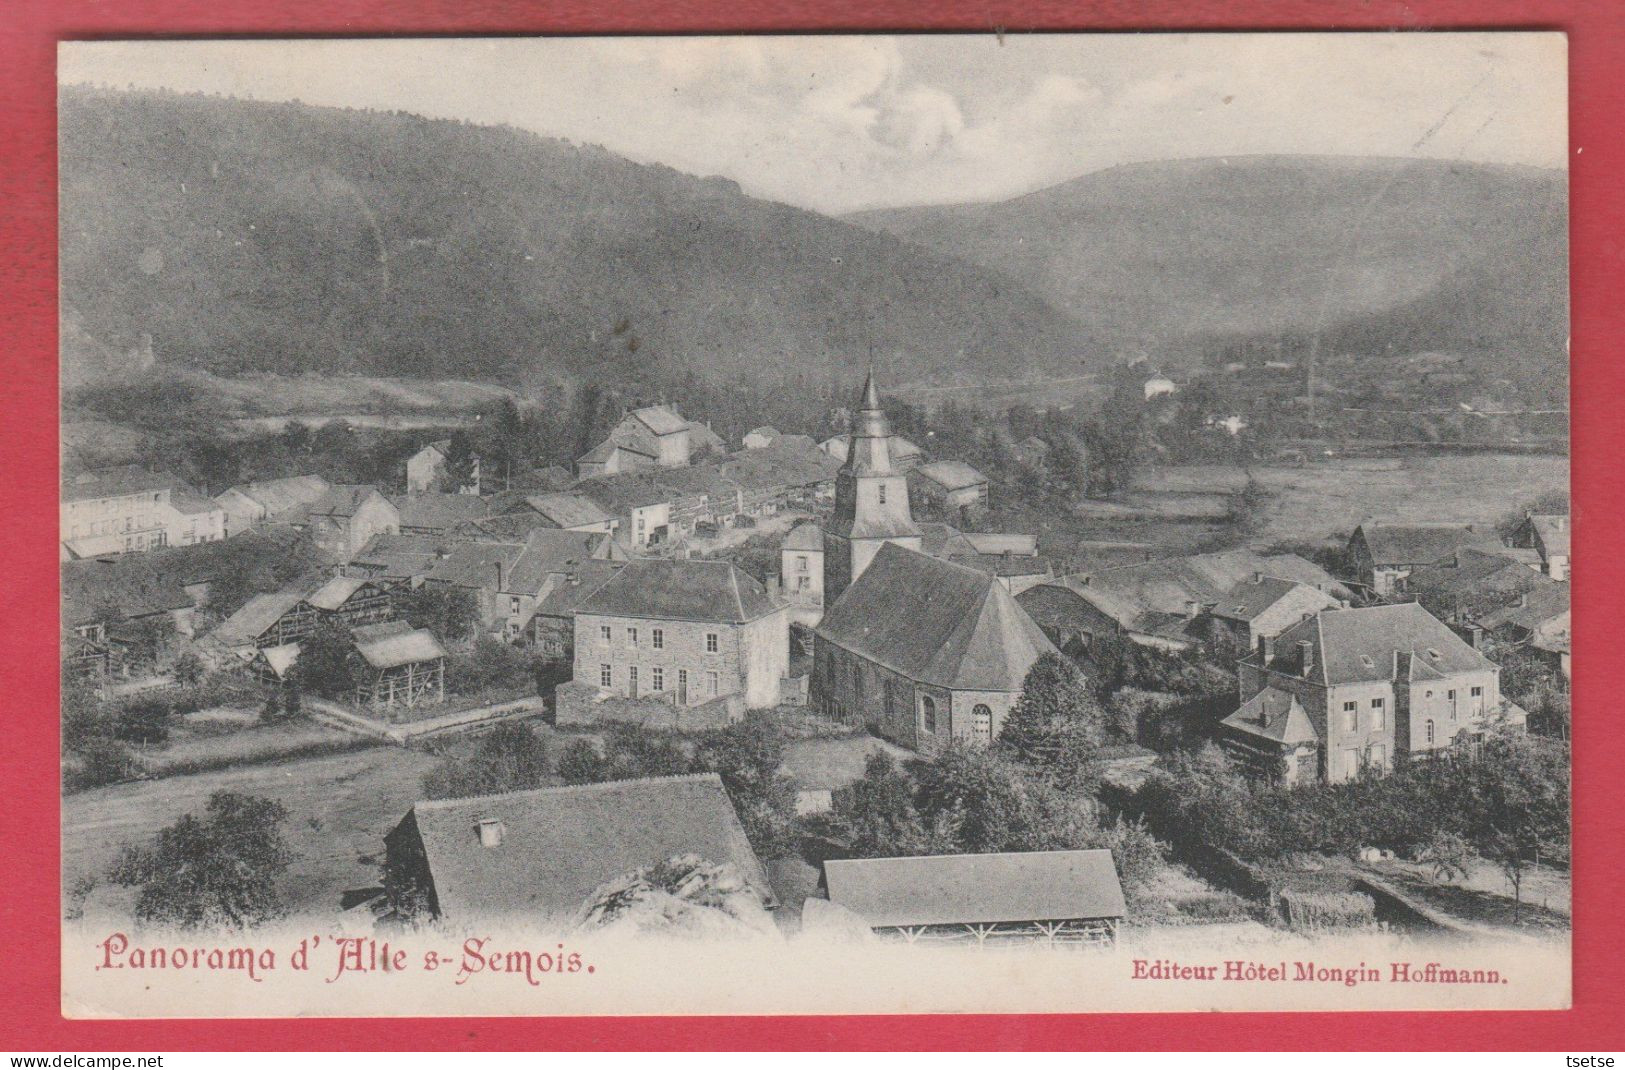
850;156;1568;374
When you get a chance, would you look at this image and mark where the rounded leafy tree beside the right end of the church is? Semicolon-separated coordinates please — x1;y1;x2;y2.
998;652;1105;790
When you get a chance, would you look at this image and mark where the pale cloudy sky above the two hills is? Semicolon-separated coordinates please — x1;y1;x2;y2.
59;33;1568;213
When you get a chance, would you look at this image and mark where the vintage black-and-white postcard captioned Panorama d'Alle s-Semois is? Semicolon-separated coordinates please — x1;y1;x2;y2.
59;33;1584;1018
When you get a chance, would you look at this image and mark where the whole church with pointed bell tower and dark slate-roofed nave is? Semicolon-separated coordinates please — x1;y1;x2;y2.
809;371;1055;753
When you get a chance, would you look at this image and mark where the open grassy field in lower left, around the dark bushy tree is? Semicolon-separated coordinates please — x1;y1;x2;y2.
62;746;437;914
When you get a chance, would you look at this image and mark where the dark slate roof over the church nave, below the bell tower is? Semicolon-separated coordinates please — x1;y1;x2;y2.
817;543;1055;691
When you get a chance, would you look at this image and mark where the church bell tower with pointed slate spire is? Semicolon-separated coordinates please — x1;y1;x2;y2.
824;368;920;605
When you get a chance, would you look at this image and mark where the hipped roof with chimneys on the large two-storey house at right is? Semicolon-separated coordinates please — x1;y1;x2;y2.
1248;602;1495;685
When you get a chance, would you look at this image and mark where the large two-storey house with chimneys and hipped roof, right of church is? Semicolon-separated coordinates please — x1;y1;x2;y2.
1225;602;1523;784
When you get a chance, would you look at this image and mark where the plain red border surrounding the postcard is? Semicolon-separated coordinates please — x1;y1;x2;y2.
0;0;1625;1054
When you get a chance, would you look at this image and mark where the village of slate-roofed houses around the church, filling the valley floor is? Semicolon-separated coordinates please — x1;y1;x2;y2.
60;364;1571;945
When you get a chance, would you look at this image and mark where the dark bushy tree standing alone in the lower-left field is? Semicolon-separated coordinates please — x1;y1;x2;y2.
111;792;293;929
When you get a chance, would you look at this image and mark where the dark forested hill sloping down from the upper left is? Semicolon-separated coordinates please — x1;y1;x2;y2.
60;88;1115;387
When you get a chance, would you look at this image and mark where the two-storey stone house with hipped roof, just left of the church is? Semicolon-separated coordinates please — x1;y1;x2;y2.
574;561;790;709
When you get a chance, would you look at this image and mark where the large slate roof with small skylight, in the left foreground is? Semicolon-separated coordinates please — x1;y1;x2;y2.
392;772;772;920
